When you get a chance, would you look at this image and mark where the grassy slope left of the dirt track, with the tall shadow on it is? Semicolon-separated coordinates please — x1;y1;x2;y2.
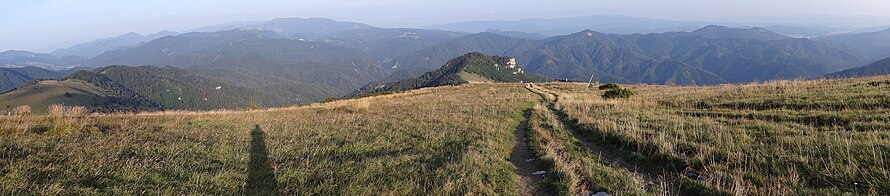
0;84;534;195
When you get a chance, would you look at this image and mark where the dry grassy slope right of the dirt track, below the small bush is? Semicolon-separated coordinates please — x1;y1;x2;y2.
545;76;890;195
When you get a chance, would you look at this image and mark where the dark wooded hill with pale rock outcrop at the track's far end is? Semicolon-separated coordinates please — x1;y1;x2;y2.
347;52;546;97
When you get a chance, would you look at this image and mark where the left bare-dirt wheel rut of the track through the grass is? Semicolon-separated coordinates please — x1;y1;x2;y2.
510;111;549;195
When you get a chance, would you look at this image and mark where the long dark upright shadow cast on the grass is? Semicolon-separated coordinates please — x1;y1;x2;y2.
245;125;281;195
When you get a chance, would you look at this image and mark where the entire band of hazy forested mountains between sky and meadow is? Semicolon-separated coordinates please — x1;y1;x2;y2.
0;18;890;113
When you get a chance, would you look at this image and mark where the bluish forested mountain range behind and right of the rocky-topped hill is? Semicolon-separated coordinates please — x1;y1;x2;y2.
385;25;867;85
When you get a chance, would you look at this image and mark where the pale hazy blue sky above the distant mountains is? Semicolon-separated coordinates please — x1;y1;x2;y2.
0;0;890;52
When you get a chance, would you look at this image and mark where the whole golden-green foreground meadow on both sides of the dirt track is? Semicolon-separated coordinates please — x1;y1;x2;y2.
0;76;890;195
